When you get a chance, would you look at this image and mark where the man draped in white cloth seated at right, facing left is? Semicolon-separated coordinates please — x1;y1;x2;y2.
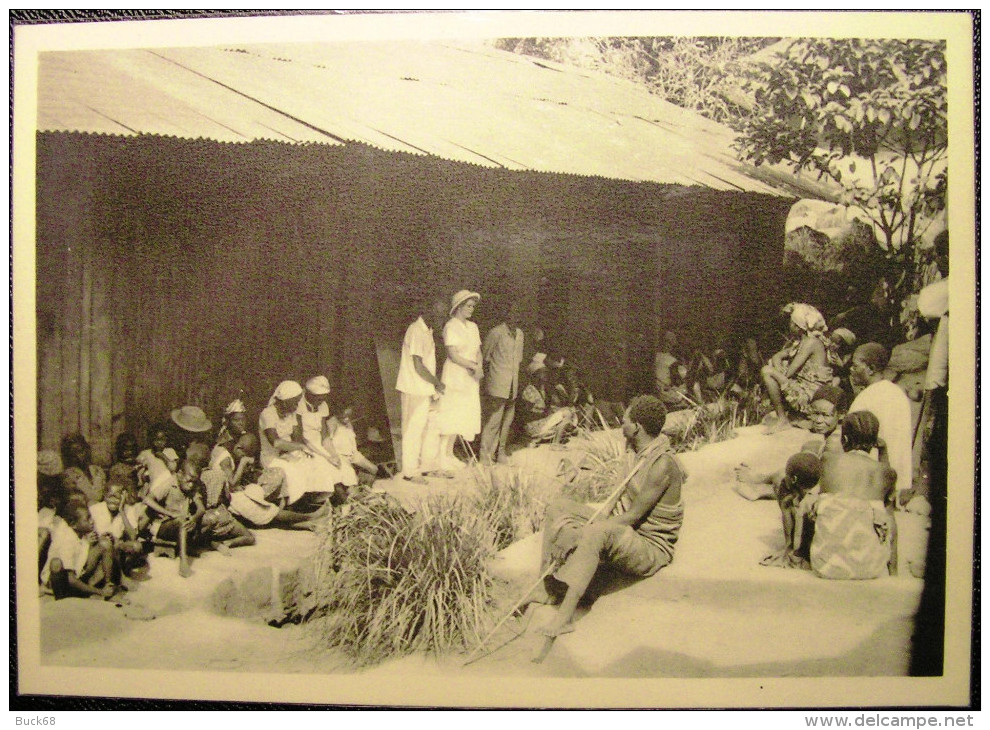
849;342;914;504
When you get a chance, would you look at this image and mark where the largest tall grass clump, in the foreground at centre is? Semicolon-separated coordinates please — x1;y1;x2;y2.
310;494;493;666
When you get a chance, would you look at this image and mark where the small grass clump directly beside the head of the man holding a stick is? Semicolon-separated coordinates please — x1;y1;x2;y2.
561;428;635;502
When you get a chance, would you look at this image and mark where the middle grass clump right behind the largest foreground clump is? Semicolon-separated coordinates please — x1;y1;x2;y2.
468;464;560;550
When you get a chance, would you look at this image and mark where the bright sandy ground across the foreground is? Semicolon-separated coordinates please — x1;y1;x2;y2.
33;420;927;679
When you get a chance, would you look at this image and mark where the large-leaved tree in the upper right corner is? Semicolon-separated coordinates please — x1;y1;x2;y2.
737;39;947;270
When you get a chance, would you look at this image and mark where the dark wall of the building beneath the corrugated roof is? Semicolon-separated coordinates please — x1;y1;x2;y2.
37;134;791;461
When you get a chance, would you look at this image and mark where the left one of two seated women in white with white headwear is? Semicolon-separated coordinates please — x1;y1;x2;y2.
258;380;343;505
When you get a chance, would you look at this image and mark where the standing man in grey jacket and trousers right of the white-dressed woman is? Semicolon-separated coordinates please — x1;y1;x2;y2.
481;304;523;463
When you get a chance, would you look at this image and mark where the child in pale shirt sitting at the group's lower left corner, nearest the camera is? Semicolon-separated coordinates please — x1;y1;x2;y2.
41;499;117;600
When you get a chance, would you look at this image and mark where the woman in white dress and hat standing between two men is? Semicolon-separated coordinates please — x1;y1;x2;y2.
439;289;484;470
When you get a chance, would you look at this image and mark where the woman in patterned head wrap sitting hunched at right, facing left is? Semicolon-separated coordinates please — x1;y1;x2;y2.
761;303;838;433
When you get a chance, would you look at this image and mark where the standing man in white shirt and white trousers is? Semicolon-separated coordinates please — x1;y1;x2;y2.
395;298;447;484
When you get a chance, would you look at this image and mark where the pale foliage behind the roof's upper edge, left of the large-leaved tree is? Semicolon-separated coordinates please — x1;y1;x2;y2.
495;37;777;123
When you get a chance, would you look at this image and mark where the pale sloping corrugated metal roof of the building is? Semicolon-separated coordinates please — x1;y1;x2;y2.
38;42;829;197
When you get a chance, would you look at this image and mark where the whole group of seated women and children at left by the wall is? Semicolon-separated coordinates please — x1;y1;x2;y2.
38;376;378;599
